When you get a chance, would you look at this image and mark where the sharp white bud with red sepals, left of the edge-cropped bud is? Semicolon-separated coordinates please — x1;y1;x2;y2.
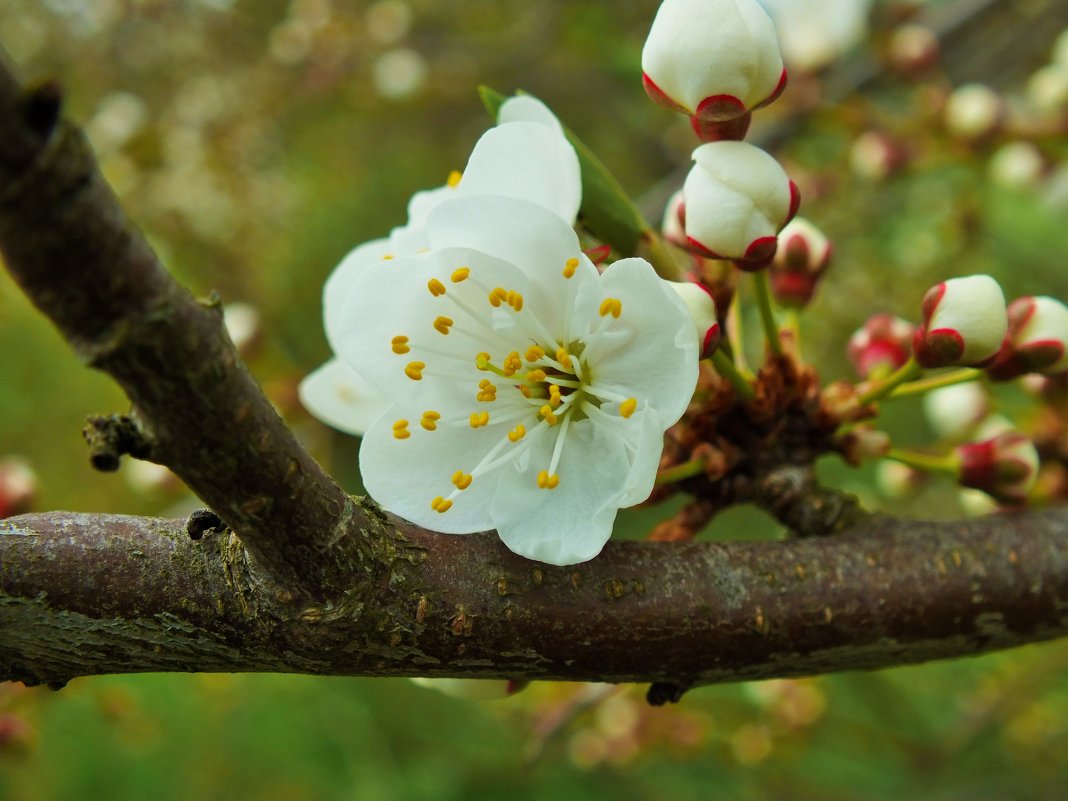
912;276;1008;367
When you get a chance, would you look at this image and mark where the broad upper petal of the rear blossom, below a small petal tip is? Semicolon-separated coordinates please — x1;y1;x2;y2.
456;122;582;225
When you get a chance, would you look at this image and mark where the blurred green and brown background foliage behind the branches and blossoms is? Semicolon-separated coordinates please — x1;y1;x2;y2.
0;0;1068;801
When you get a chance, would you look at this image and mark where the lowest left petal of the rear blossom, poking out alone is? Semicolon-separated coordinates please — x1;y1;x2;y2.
299;359;389;437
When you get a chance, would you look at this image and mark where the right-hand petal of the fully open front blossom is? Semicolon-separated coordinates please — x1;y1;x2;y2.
585;258;698;430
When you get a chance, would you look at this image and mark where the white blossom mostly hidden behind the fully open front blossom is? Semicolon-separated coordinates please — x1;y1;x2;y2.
300;96;582;436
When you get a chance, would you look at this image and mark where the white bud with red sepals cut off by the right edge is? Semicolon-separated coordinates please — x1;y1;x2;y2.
987;297;1068;381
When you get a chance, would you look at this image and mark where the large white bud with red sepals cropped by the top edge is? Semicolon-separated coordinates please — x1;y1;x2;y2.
642;0;786;136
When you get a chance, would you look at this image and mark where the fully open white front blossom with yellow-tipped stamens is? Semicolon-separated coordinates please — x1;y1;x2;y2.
328;195;698;565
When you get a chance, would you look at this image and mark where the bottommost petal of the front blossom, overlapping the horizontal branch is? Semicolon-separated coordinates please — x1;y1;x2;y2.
492;420;630;565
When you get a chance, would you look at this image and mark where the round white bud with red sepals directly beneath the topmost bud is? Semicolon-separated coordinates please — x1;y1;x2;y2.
682;142;800;268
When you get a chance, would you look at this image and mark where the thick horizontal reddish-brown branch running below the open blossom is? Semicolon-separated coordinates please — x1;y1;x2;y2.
0;511;1068;688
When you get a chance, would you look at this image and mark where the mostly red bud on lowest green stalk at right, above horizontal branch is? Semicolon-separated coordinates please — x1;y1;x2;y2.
957;431;1038;505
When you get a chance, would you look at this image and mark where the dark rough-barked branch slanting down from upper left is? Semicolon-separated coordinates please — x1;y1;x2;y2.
0;53;366;594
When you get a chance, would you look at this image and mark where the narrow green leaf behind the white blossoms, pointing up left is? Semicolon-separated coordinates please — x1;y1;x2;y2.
478;87;678;279
